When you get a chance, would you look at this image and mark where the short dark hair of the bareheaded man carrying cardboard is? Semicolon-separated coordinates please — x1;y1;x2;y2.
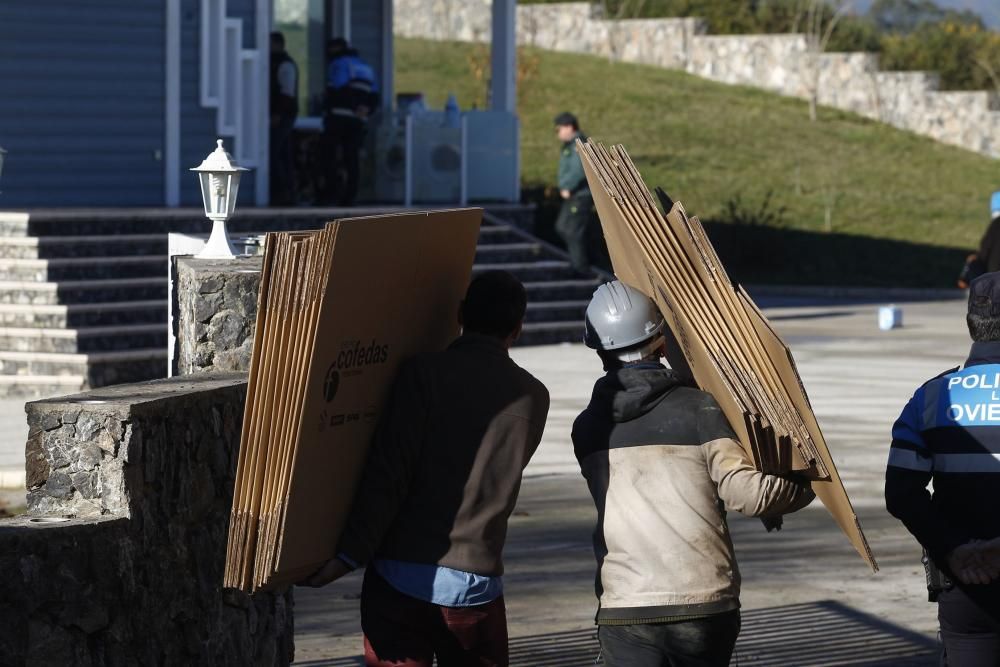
460;271;528;338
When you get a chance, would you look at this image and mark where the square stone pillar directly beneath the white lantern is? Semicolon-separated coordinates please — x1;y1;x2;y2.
174;257;262;375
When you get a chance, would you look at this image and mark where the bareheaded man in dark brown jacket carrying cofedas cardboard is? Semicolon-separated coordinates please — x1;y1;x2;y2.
306;271;549;667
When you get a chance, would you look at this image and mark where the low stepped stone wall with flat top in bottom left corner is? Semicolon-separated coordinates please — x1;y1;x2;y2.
0;374;293;667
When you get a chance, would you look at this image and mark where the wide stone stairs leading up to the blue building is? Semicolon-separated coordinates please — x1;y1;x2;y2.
0;207;602;397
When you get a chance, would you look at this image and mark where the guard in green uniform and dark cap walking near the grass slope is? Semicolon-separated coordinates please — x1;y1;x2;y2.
555;113;595;272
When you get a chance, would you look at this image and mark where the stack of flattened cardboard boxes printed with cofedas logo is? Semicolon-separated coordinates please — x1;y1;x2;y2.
225;209;482;591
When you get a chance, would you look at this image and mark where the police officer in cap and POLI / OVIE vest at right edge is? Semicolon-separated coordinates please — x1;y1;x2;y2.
885;273;1000;667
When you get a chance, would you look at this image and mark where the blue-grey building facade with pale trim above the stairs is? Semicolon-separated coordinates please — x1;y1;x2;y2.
0;0;519;209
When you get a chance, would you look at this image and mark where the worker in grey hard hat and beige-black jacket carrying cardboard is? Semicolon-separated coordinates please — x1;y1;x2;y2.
573;281;814;667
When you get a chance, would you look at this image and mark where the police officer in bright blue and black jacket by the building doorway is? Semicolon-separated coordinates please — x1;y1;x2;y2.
320;37;379;206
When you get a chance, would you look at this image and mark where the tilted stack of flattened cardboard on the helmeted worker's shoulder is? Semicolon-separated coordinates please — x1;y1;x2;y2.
577;142;877;570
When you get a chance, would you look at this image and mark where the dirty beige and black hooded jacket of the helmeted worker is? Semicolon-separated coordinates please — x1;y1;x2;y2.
573;363;813;624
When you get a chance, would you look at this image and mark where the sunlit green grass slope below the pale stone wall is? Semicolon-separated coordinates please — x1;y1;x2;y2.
395;39;1000;256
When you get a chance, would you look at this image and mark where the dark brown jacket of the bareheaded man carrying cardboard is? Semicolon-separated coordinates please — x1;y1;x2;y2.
338;334;549;576
